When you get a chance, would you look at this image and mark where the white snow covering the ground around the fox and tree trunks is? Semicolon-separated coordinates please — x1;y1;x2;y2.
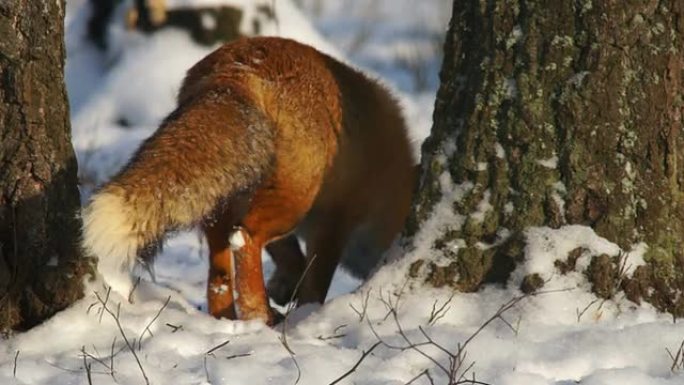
0;0;684;385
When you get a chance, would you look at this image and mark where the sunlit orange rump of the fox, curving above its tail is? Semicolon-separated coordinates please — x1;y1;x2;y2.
178;38;343;205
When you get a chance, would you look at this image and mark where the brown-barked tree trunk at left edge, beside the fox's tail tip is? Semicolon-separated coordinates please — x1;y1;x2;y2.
0;0;90;331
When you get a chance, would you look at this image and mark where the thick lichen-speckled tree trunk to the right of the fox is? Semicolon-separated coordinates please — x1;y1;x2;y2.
407;0;684;316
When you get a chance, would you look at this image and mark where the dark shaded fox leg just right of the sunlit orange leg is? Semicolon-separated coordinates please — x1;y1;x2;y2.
266;234;306;306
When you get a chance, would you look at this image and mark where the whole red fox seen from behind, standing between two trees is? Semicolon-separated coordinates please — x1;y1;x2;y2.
82;38;414;323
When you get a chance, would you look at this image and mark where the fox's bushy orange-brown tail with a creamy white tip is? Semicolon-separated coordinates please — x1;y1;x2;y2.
82;89;275;296
